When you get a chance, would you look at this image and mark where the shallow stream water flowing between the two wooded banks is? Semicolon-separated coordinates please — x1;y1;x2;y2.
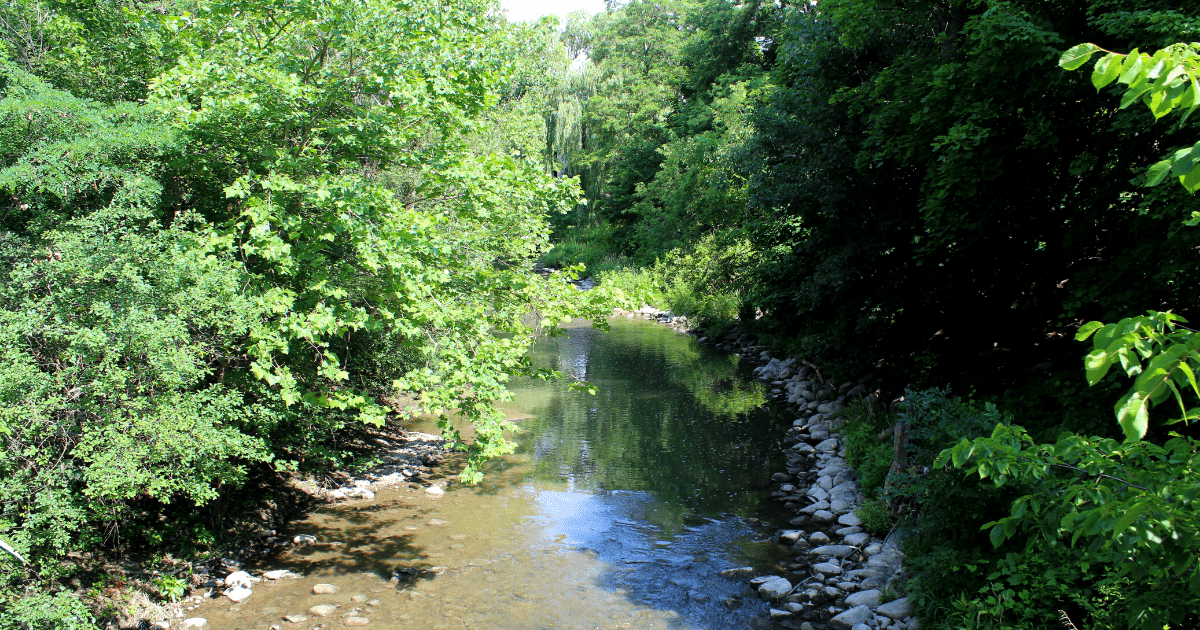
199;319;784;630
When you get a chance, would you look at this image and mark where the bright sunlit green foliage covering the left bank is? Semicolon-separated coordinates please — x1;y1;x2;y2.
0;0;609;628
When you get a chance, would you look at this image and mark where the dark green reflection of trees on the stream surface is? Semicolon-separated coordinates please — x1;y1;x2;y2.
520;323;778;523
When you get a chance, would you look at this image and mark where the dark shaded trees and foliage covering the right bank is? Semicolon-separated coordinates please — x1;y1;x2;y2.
537;0;1200;629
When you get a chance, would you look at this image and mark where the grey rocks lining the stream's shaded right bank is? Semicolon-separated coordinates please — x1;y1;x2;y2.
700;328;918;630
